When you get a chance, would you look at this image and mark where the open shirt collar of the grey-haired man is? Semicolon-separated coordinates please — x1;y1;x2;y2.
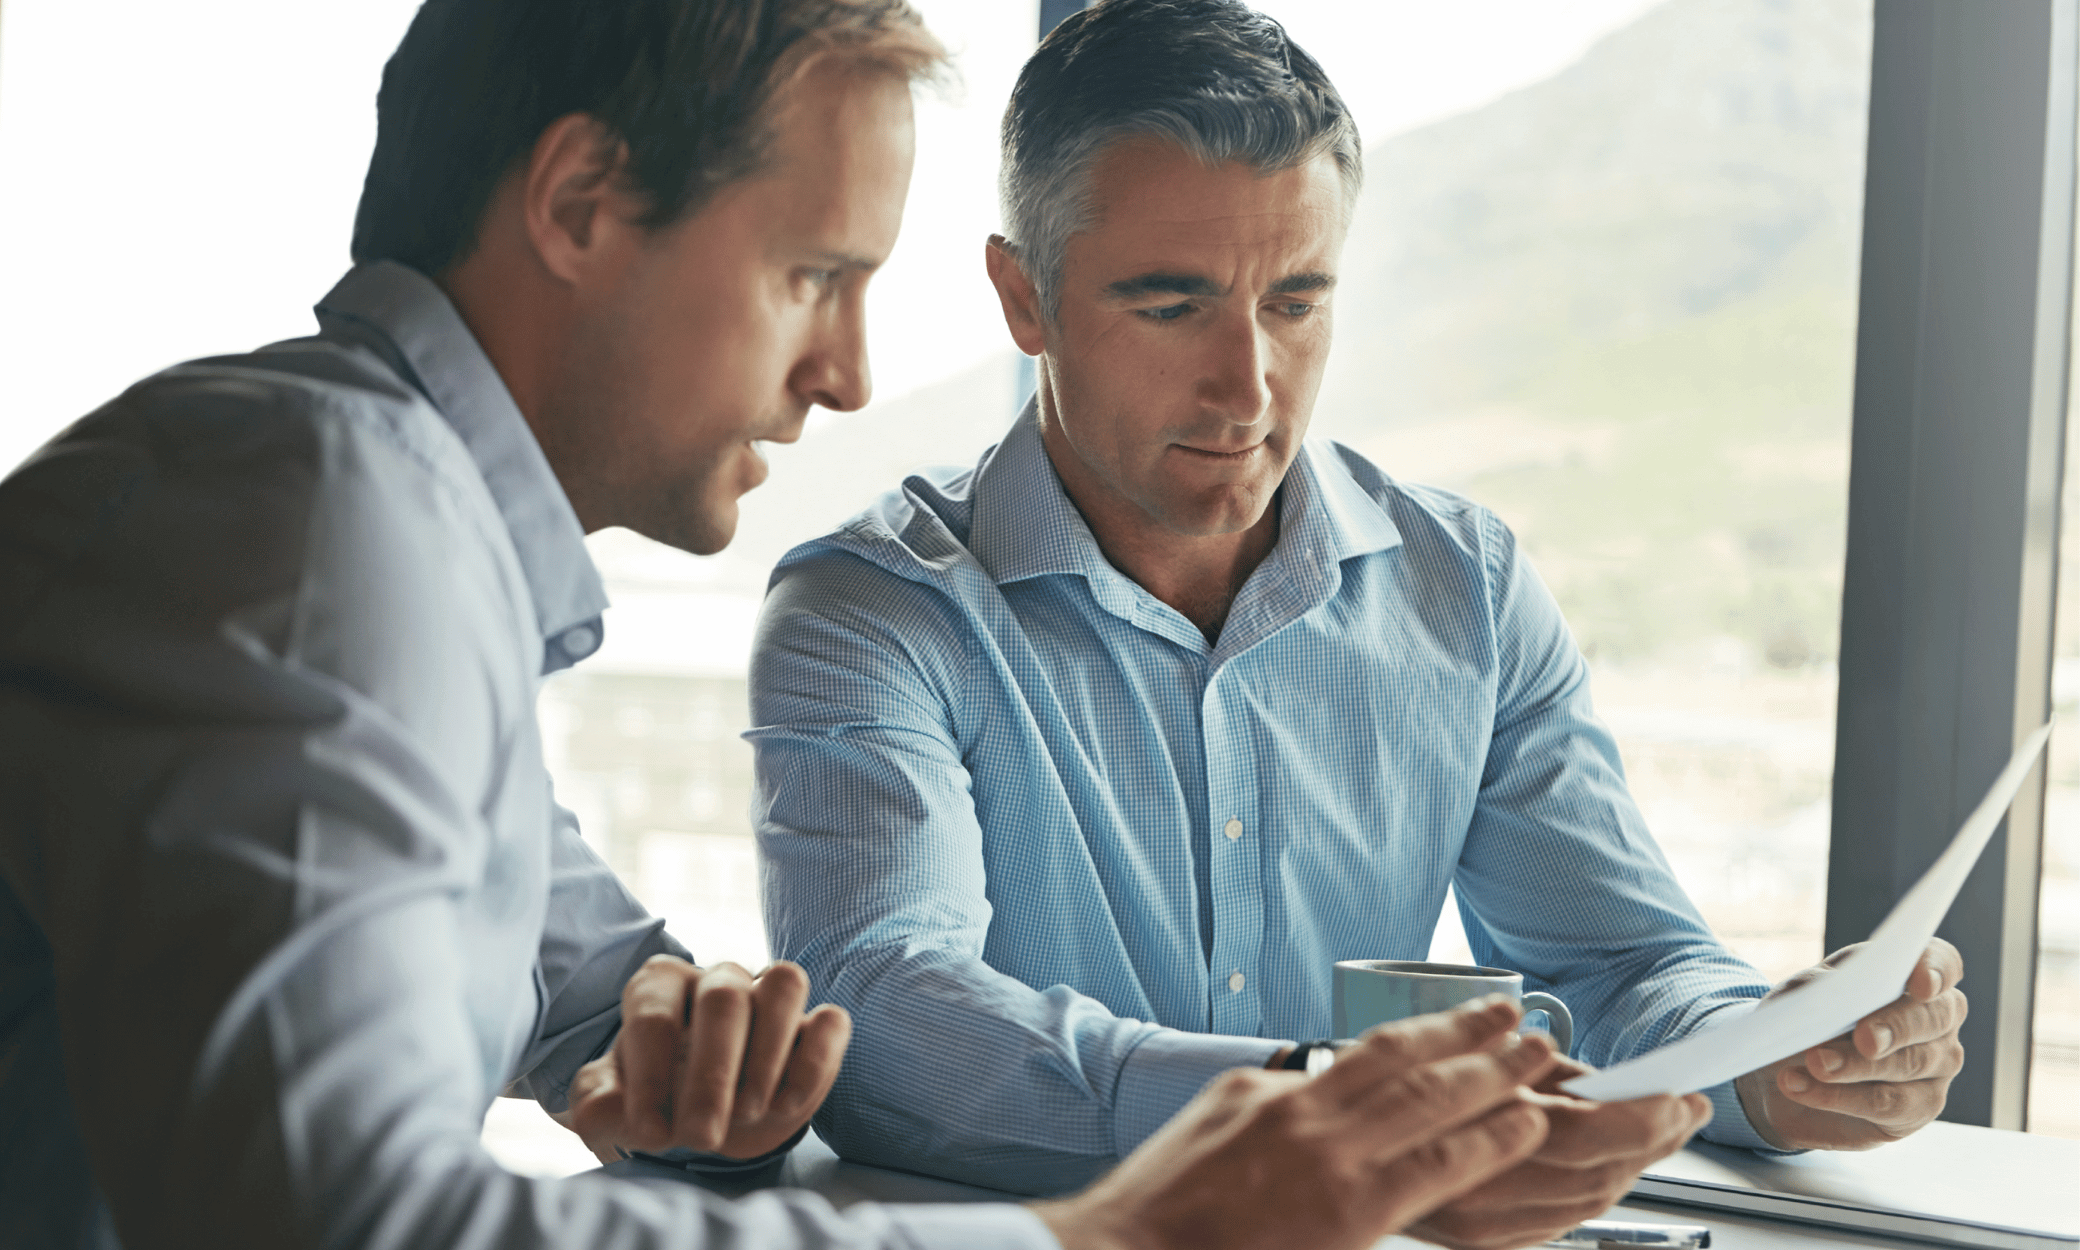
967;399;1402;653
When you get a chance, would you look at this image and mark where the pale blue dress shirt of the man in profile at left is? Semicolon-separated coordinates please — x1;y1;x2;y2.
0;264;1052;1250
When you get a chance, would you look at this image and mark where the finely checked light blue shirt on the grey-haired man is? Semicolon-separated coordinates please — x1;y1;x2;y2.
747;406;1766;1192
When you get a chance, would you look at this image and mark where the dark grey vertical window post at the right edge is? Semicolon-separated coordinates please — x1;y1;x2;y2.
1826;0;2076;1127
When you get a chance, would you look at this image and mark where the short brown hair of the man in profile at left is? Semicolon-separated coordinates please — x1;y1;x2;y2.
354;0;944;275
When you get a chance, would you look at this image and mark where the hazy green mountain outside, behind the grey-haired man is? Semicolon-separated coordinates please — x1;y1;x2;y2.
722;0;1870;668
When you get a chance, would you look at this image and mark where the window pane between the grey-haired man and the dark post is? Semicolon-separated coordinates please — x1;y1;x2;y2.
1263;0;1870;980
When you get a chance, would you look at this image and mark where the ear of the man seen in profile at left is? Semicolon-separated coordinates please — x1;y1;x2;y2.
520;112;639;285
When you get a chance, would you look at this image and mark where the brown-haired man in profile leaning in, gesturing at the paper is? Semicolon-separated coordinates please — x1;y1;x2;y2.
0;0;1589;1250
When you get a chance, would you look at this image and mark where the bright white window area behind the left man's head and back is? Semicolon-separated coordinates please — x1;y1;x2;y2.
0;0;418;468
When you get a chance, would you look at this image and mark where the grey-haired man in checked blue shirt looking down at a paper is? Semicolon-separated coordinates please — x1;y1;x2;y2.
751;0;1964;1246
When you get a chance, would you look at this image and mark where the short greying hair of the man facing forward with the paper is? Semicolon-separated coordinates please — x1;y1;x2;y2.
998;0;1364;318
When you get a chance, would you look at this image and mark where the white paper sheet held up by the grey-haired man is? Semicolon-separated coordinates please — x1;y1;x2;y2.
1560;722;2051;1102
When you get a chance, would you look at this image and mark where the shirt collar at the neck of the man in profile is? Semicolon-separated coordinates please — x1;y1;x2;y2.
316;260;607;674
